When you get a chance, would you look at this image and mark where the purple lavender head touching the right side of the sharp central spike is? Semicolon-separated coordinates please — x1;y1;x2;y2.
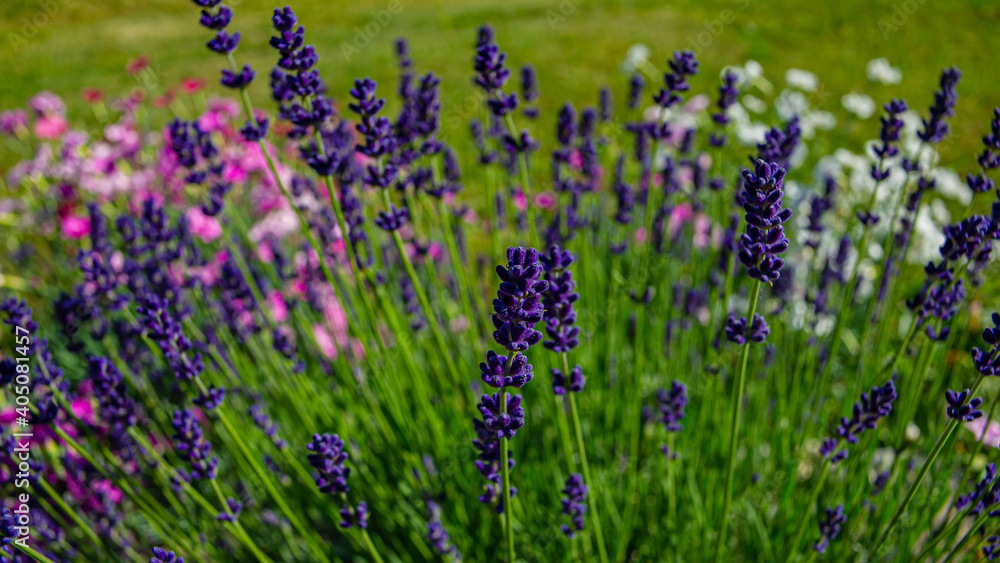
539;245;580;353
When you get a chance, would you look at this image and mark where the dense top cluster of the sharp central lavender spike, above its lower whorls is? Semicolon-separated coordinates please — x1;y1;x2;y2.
493;247;549;352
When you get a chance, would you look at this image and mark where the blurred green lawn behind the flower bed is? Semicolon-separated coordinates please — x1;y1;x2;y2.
0;0;1000;162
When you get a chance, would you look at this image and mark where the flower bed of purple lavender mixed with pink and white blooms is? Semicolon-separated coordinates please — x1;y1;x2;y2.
0;5;1000;563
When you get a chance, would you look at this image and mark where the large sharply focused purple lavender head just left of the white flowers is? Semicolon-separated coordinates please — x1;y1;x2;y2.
739;160;792;283
